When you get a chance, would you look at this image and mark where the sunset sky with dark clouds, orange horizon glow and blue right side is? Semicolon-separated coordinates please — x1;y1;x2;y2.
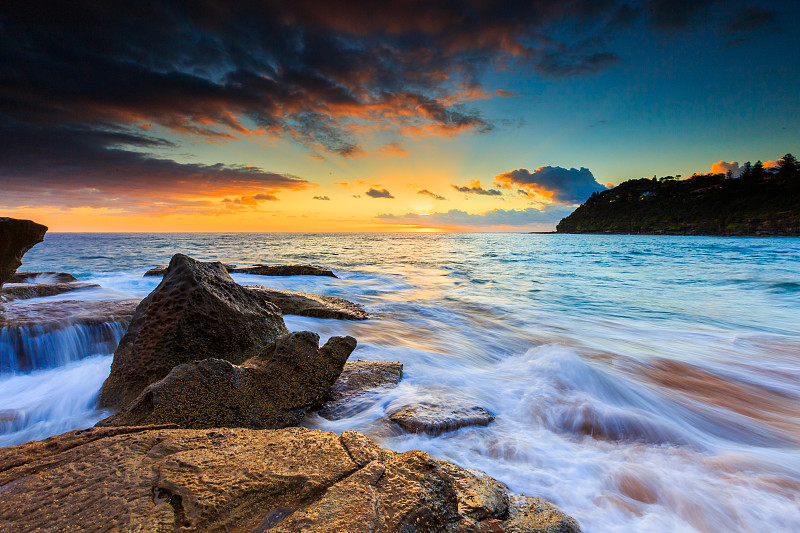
0;0;800;232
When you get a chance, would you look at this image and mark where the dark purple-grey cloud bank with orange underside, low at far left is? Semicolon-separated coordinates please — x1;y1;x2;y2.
0;123;310;211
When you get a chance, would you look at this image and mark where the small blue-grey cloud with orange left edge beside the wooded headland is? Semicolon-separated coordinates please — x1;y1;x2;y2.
495;167;605;204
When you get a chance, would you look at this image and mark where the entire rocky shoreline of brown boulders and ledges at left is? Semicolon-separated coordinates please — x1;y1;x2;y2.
0;219;580;533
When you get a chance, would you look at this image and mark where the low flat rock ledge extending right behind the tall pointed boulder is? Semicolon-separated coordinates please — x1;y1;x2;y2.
244;285;369;320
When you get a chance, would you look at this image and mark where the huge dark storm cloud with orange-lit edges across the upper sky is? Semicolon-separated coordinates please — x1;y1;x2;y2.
0;0;760;203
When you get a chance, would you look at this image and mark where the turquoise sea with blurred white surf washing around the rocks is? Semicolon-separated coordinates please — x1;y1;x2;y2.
0;234;800;532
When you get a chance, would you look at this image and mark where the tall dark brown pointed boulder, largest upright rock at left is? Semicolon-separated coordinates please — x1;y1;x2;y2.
99;254;288;409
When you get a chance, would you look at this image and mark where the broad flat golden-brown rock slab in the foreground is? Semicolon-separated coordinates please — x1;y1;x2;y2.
0;426;577;533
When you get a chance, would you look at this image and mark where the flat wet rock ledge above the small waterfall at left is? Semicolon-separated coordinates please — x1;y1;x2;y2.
0;300;139;332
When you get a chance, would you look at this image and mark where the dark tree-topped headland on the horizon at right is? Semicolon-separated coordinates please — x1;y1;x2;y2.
556;172;800;236
